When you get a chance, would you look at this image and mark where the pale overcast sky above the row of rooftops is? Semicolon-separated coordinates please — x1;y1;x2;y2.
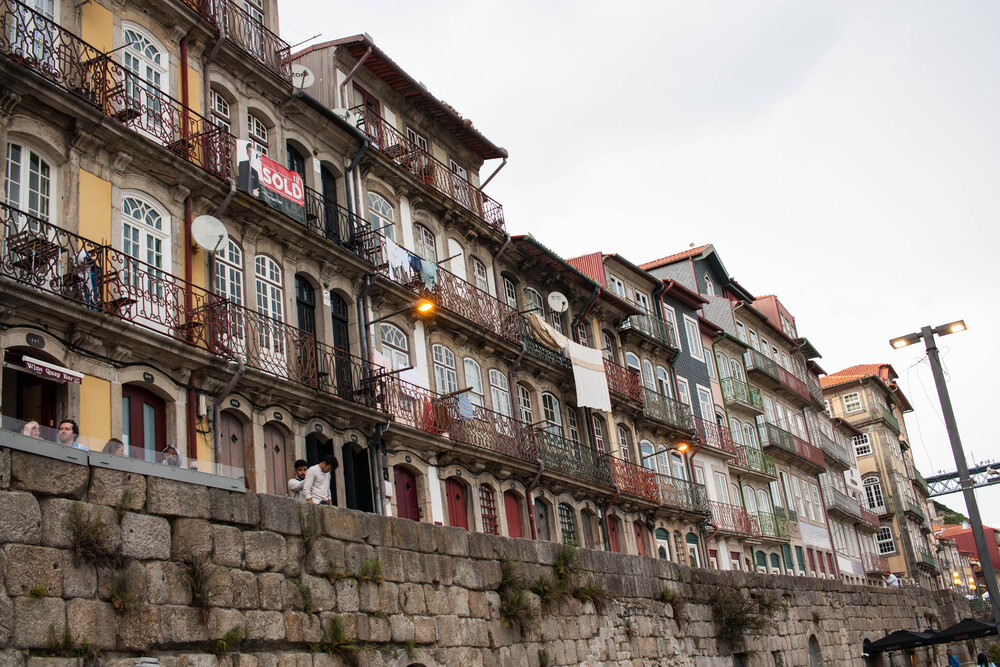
280;0;1000;527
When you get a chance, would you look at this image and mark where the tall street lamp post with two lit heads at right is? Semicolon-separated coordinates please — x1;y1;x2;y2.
889;320;1000;624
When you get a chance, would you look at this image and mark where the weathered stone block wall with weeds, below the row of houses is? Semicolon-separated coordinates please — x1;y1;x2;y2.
0;449;968;667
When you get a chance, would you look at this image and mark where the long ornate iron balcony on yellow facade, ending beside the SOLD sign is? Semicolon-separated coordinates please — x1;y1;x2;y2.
0;0;235;180
